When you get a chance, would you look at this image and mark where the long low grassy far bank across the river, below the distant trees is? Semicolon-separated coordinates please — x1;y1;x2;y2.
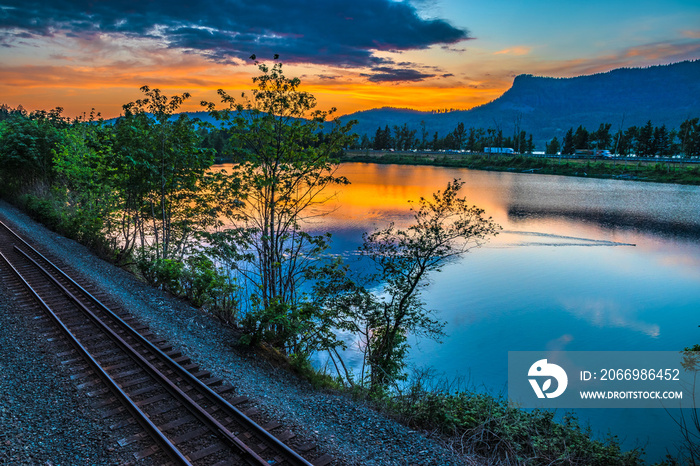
340;151;700;186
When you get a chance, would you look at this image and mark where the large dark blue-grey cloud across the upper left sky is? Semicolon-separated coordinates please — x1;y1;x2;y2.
0;0;469;69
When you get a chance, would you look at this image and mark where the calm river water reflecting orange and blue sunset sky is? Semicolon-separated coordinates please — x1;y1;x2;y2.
307;164;700;459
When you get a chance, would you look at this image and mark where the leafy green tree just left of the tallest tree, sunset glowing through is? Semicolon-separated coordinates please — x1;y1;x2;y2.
111;86;218;260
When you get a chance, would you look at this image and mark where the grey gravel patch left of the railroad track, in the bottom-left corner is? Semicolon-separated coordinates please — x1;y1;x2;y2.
0;264;133;465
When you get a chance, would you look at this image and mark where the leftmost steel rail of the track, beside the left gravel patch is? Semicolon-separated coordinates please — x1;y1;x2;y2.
0;252;192;466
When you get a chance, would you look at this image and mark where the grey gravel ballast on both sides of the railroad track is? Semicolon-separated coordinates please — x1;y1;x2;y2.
0;202;477;466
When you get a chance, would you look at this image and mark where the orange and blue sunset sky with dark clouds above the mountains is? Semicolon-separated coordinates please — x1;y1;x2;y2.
0;0;700;118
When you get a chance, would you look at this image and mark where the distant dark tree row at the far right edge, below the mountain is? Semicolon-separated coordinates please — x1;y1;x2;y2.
546;118;700;157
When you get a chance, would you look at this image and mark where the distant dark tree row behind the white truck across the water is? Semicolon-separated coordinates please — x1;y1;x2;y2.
352;121;535;153
